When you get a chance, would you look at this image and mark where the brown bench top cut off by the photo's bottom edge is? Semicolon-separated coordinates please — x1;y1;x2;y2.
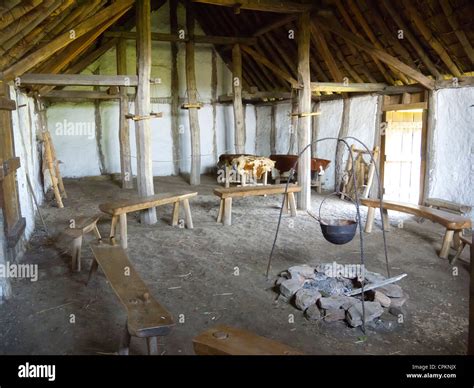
193;325;303;356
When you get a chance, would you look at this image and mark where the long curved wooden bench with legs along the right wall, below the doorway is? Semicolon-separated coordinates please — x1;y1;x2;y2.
360;199;471;259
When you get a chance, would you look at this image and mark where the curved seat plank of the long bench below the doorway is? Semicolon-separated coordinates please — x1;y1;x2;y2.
360;198;471;230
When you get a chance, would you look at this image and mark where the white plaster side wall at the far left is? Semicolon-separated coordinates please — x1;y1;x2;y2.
10;88;43;239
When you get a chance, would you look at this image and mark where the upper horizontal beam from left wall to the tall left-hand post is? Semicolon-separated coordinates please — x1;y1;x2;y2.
19;73;138;86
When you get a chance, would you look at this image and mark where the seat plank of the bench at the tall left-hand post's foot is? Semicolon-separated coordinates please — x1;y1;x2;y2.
99;191;197;216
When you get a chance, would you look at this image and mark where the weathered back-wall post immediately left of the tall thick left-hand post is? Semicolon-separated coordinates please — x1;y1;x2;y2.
116;39;133;189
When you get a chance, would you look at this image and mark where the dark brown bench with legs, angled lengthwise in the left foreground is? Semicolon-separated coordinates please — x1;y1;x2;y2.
88;243;174;355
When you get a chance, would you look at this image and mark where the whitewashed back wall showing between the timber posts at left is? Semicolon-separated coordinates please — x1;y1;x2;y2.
47;0;232;177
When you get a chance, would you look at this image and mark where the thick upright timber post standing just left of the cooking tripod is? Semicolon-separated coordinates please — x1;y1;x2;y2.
298;13;311;210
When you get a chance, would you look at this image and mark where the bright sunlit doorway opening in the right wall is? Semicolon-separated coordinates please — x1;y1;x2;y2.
381;109;424;204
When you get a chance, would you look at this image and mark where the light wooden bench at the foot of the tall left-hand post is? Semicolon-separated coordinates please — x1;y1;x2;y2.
99;191;197;249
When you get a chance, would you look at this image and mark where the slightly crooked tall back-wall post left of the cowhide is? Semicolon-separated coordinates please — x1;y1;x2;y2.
186;3;201;185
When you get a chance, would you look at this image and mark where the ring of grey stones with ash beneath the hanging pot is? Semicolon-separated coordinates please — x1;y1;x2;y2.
276;262;408;328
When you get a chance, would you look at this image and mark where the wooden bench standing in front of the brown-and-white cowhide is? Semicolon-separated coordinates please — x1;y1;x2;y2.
214;184;301;225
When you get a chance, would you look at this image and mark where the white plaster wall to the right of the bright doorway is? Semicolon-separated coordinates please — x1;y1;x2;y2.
428;88;474;218
